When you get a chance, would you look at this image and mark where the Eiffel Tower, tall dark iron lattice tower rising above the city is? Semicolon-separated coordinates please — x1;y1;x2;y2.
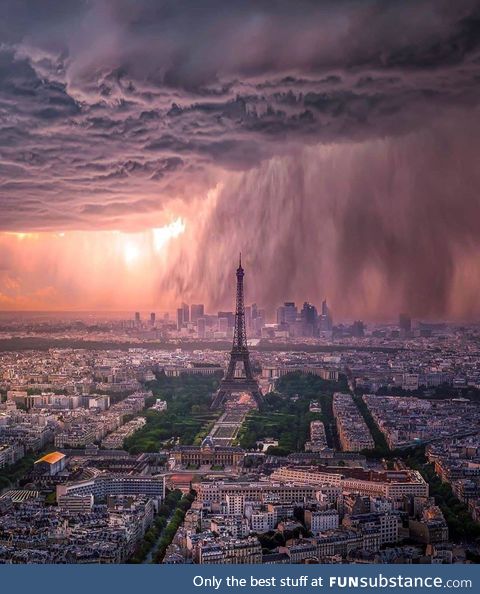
211;254;262;408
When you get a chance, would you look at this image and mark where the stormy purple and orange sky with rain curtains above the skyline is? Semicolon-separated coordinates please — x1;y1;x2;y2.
0;0;480;320
